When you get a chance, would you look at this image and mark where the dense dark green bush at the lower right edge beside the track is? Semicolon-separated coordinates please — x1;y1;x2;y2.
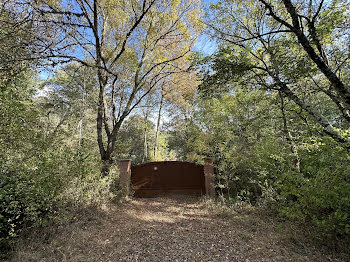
276;141;350;238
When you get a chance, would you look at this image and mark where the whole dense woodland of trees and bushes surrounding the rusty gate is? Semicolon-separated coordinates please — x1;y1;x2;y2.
0;0;350;256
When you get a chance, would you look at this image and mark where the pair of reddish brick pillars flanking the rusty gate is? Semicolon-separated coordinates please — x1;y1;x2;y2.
119;157;215;198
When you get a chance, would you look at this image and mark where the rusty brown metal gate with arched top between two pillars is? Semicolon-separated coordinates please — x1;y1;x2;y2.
131;161;205;197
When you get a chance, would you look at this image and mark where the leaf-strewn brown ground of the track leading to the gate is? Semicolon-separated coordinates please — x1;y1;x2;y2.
6;196;341;262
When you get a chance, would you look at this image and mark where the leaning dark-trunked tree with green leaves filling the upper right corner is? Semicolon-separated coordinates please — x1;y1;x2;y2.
207;0;350;150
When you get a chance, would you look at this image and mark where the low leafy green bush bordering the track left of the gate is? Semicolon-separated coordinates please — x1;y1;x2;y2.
0;144;118;255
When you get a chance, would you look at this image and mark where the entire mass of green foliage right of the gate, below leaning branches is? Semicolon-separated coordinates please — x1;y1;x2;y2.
171;79;350;243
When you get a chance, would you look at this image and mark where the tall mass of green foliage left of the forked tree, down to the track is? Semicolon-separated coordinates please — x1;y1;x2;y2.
0;67;118;256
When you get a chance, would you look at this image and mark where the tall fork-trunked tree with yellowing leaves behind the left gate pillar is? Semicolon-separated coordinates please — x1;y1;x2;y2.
34;0;202;175
